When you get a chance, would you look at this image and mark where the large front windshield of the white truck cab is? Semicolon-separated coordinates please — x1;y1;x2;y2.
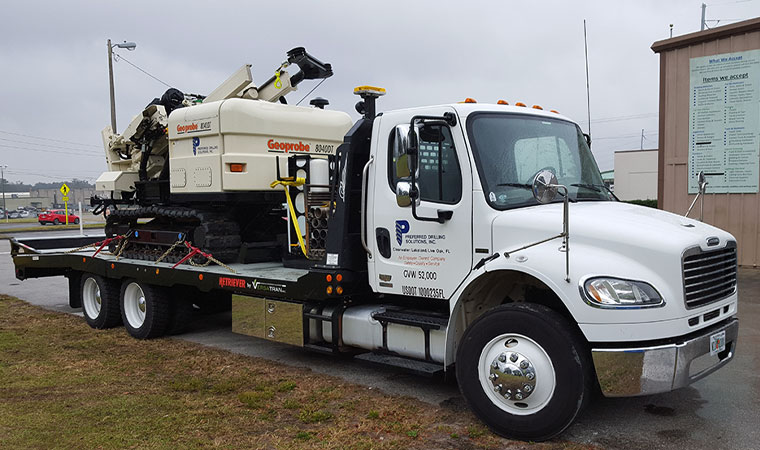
467;113;614;209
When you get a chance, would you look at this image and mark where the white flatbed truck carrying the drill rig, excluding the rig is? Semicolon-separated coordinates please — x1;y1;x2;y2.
11;76;738;441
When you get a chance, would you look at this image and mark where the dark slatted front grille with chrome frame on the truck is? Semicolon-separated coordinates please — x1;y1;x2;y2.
683;242;736;308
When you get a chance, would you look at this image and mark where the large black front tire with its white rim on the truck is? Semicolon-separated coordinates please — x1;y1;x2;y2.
456;303;592;441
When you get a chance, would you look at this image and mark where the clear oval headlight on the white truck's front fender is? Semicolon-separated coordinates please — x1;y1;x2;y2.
583;278;665;308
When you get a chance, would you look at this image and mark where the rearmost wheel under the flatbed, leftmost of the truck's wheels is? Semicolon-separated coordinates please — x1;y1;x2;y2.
79;273;121;330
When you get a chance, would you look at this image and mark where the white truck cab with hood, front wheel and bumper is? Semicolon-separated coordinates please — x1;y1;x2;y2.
354;99;738;439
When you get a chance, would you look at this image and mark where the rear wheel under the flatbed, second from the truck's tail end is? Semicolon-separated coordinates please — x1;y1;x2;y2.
120;280;170;339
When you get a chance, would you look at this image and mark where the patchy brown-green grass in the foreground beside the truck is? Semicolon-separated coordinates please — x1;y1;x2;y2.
0;296;592;449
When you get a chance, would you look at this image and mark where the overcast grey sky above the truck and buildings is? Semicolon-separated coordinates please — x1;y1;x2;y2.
0;0;760;182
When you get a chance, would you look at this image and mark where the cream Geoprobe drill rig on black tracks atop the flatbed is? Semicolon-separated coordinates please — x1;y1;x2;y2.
91;47;351;265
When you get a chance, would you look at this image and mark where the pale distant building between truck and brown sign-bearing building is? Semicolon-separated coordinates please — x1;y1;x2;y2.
615;149;657;200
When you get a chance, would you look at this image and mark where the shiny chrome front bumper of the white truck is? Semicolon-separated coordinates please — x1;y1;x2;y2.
591;318;739;397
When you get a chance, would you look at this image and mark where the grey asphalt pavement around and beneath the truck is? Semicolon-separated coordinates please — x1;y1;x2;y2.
0;230;760;450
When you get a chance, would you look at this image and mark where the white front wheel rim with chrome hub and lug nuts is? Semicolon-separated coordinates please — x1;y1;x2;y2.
478;333;557;416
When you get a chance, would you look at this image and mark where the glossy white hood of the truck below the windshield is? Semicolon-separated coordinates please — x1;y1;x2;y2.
492;202;733;258
